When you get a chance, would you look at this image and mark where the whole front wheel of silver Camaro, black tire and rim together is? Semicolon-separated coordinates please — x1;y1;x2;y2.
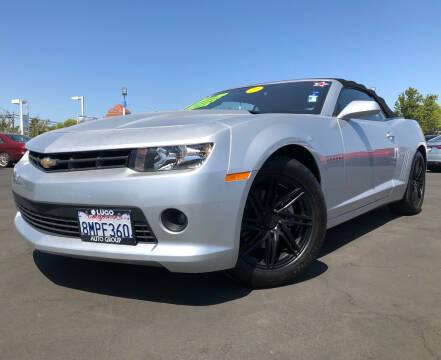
227;158;327;288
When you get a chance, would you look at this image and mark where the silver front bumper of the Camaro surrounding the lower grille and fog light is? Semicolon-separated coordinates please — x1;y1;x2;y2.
13;150;252;272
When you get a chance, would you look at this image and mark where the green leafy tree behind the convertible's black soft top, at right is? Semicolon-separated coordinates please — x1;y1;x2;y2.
395;87;441;134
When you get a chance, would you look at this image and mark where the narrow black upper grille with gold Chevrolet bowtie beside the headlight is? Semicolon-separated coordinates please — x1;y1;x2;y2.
29;149;131;172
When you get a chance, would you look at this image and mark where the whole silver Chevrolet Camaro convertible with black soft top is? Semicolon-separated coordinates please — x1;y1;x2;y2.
13;79;426;287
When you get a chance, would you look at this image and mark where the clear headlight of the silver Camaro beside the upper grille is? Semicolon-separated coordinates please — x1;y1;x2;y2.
130;143;213;171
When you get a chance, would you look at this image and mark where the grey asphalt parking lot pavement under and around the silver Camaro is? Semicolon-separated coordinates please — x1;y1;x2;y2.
0;169;441;360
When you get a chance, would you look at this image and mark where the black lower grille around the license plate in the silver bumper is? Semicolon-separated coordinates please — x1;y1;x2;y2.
14;194;157;243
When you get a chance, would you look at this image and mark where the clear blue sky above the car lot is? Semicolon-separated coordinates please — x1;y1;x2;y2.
0;0;441;122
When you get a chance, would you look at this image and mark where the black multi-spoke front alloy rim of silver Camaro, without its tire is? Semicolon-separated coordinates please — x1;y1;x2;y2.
239;174;313;269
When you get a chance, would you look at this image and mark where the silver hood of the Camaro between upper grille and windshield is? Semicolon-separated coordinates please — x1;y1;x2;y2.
26;110;249;153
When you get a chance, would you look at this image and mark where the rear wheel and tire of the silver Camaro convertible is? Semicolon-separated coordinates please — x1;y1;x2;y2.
389;151;426;215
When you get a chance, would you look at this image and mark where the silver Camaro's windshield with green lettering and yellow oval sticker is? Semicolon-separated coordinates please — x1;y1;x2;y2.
185;81;331;114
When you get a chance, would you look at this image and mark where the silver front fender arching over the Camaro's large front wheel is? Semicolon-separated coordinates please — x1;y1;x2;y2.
228;114;345;215
